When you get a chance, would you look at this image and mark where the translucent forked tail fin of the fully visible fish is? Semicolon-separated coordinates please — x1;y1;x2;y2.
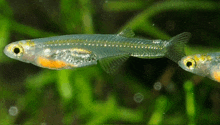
165;32;191;63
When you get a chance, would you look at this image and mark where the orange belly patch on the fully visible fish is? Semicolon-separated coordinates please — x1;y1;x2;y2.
37;57;71;69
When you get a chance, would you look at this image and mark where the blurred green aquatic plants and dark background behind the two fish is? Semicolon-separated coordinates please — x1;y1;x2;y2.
0;0;220;125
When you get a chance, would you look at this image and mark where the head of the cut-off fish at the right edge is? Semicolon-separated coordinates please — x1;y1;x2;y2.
178;54;212;77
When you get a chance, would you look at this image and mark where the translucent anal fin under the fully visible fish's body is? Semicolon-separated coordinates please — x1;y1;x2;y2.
99;54;130;74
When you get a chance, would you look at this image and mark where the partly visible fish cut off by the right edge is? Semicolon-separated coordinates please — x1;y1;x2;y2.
178;52;220;82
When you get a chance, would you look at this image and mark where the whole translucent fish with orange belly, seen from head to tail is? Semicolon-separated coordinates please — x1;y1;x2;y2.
4;28;190;73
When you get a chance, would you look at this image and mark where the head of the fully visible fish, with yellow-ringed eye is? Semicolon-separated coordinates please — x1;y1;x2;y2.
4;40;35;63
